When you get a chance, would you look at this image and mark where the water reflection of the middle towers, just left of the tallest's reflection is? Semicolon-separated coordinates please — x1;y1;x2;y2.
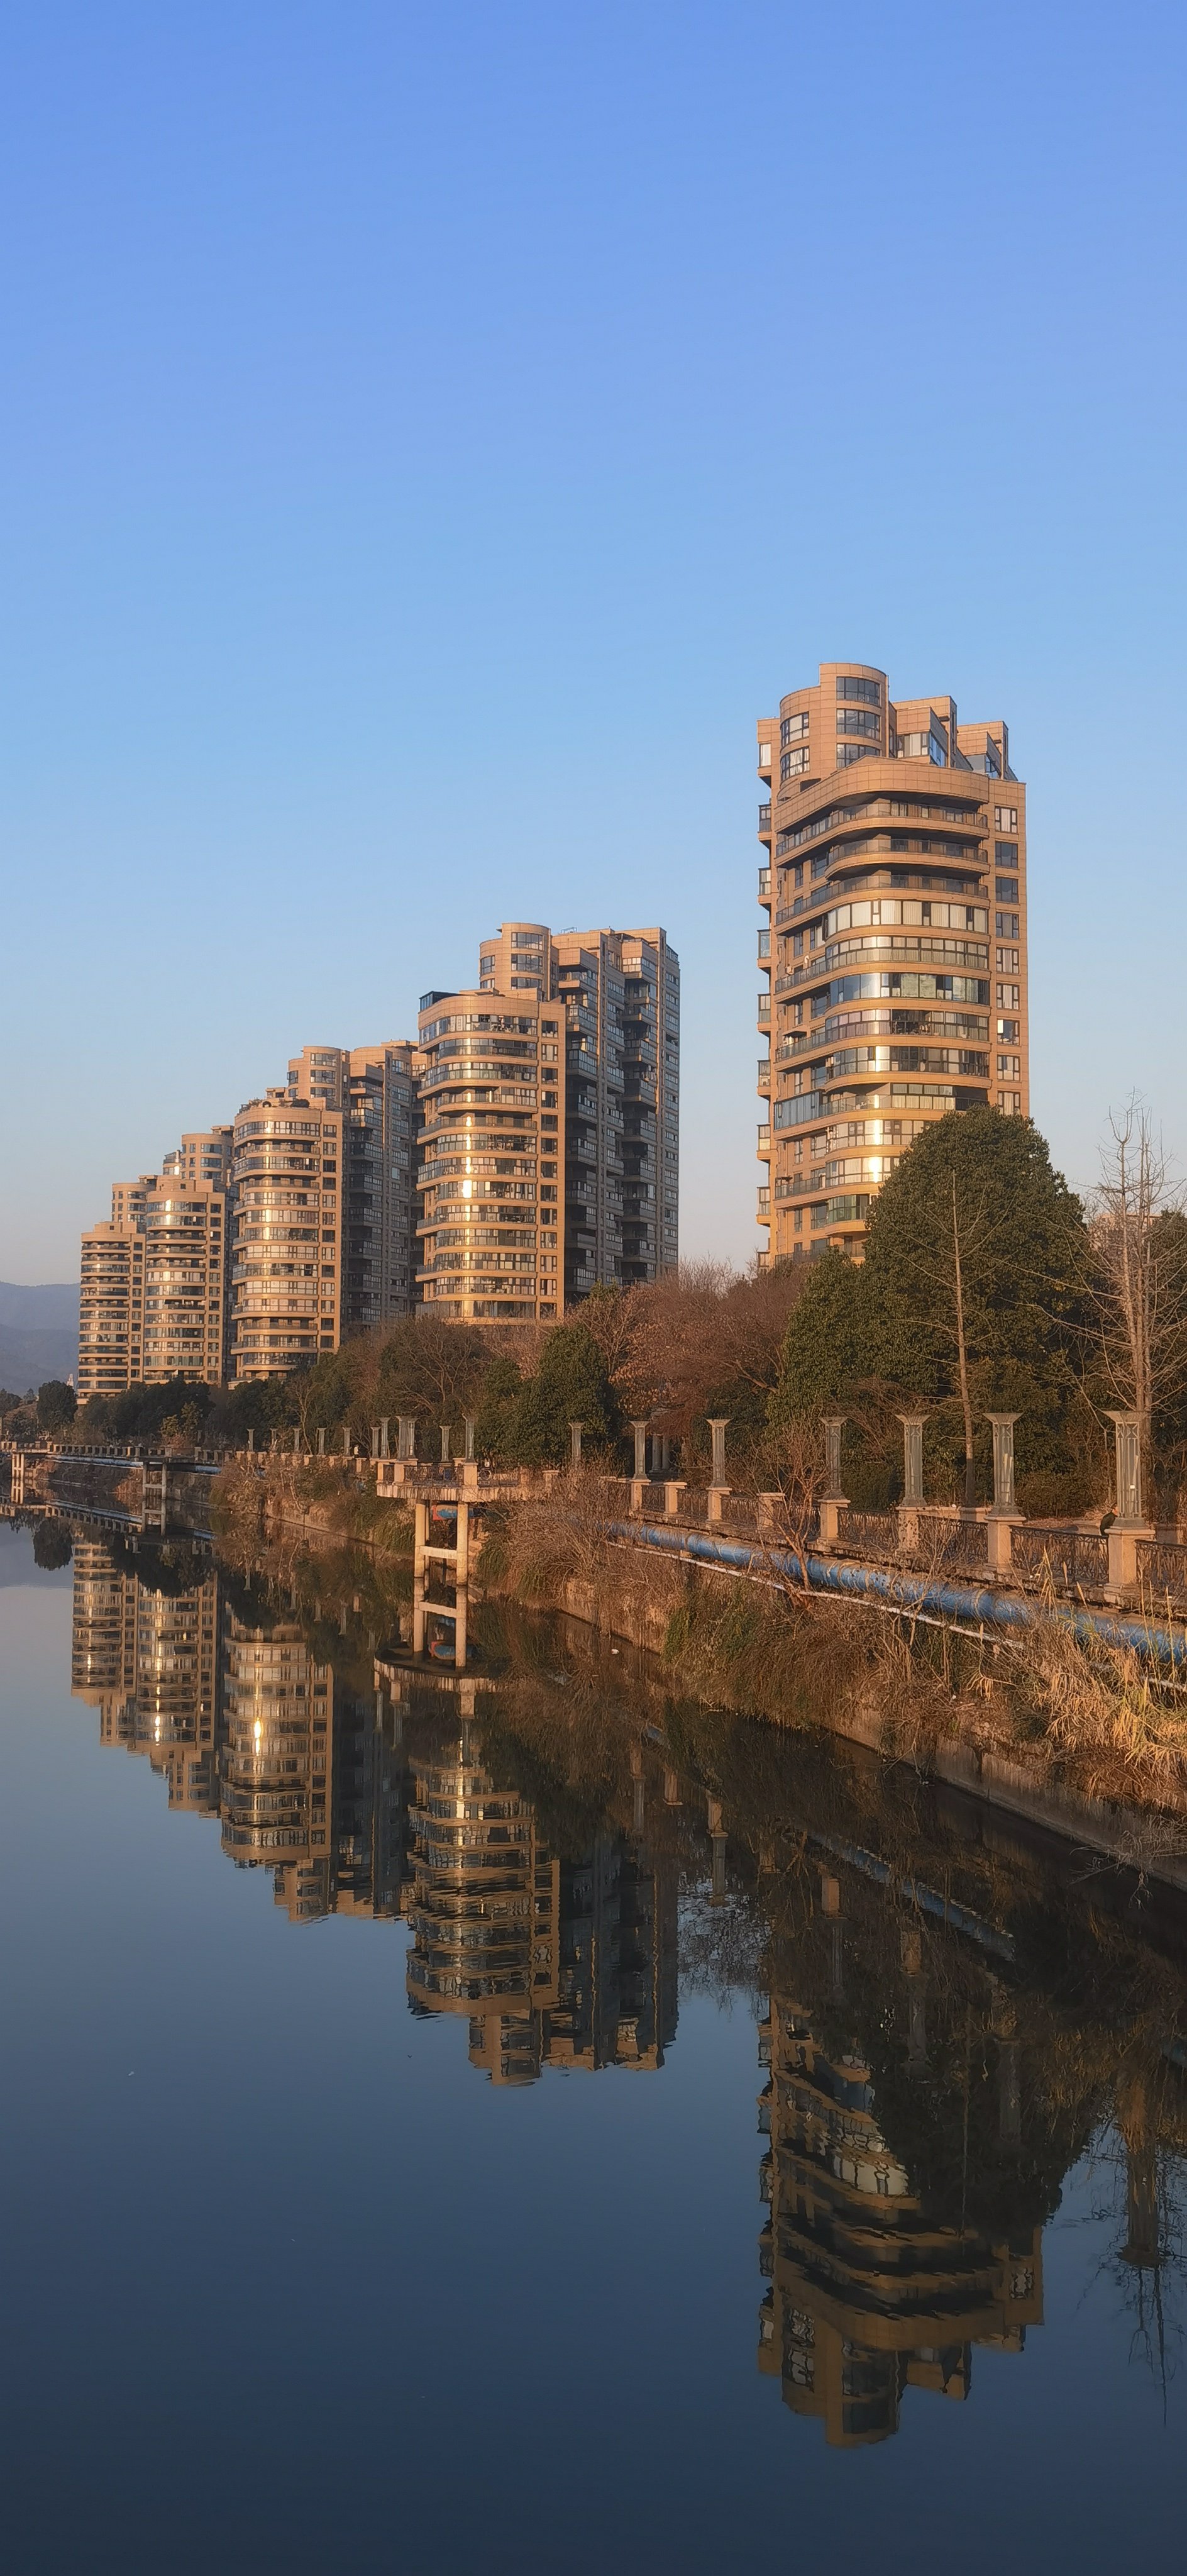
407;1721;677;2084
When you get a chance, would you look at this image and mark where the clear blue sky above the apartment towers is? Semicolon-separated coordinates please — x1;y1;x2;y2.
0;0;1187;1280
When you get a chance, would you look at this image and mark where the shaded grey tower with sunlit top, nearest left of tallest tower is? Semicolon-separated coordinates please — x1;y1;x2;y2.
479;922;680;1306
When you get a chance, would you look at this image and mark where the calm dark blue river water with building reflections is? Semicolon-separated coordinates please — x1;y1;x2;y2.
0;1525;1187;2576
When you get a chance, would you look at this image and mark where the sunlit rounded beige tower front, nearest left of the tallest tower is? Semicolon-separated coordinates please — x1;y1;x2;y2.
417;982;564;1324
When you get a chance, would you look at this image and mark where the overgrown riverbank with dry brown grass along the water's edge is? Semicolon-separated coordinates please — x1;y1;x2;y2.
214;1460;1187;1888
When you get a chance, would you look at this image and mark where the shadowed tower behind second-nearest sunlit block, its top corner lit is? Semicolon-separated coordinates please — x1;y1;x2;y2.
289;1038;420;1332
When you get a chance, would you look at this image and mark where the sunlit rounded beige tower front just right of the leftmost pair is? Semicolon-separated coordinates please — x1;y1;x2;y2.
226;1090;345;1384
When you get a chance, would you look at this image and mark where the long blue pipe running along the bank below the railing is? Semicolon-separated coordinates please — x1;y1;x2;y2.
605;1520;1187;1667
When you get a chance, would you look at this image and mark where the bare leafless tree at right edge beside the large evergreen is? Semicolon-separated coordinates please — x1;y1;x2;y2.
1089;1092;1187;1460
